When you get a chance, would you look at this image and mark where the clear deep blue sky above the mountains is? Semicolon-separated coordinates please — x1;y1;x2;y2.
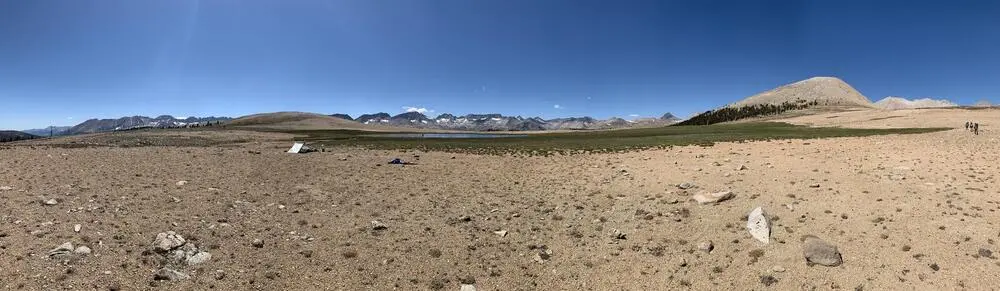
0;0;1000;129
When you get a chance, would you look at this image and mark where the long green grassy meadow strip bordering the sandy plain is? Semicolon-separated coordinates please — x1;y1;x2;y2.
283;122;946;156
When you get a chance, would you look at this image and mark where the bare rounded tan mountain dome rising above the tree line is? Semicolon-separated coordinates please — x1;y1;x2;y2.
729;77;873;108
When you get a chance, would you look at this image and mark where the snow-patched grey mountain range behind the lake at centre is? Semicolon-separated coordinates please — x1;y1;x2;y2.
330;112;679;131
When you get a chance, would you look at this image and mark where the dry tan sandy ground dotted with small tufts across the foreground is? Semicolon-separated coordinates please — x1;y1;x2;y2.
0;110;1000;290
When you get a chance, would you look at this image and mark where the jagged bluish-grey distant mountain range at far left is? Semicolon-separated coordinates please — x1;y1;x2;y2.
65;115;231;135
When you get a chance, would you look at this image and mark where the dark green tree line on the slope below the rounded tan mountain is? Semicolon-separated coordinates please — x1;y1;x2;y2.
675;100;819;125
